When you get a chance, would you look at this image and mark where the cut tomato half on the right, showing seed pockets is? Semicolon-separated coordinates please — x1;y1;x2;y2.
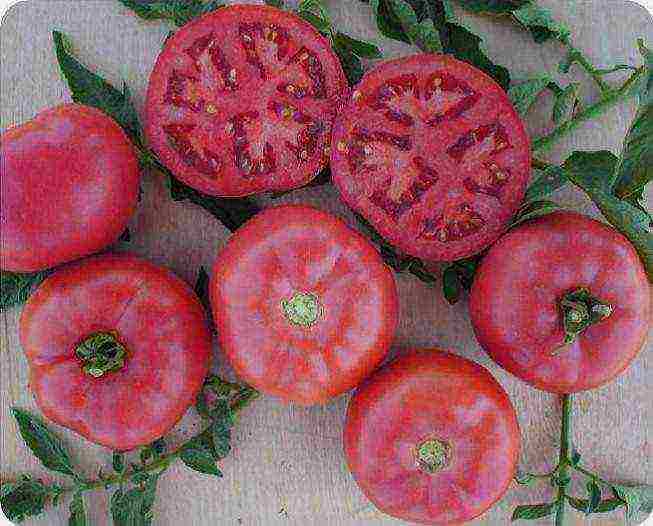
331;54;531;261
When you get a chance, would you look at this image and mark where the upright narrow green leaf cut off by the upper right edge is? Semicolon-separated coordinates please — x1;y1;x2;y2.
614;41;653;199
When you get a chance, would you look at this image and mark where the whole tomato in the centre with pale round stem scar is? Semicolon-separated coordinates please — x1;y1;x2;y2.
211;205;398;405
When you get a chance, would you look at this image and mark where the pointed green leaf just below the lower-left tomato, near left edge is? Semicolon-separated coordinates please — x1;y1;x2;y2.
11;407;76;477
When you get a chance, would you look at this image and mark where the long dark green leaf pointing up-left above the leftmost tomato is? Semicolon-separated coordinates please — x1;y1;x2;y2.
52;31;142;147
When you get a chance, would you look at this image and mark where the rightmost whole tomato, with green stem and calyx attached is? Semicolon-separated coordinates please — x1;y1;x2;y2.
470;212;651;393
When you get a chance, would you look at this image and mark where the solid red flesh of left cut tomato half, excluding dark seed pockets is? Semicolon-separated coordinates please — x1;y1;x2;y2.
145;4;348;197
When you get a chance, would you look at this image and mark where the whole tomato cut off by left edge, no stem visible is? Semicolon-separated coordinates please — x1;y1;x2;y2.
0;104;139;272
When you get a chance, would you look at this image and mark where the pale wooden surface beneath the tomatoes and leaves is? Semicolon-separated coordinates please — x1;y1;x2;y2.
0;0;653;526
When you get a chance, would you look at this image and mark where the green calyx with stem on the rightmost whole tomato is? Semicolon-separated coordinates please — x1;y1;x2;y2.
559;287;614;345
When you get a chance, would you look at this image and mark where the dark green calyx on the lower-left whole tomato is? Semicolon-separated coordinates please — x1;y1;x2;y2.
75;331;127;378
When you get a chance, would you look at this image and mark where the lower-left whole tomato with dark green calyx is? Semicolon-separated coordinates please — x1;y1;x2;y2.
20;254;211;451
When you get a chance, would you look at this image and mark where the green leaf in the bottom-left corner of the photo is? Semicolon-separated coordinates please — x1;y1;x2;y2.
0;476;62;523
